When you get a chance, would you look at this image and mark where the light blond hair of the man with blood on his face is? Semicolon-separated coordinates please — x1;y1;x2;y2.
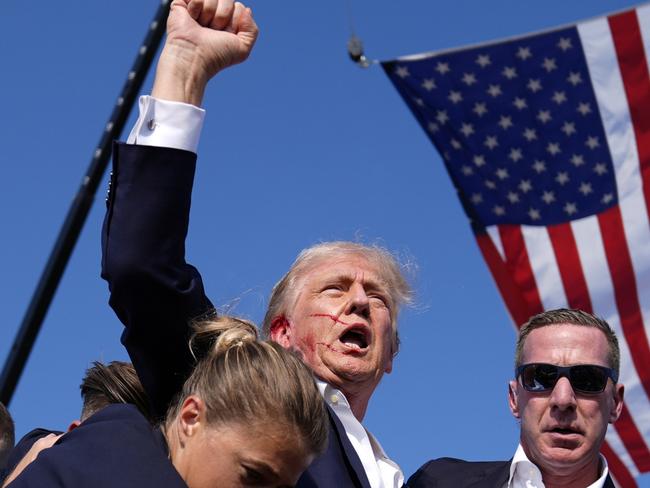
262;241;413;354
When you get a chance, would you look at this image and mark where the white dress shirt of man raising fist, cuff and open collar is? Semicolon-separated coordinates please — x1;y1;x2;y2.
127;95;404;488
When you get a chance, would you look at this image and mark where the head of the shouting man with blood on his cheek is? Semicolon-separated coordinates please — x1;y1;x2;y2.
263;242;411;412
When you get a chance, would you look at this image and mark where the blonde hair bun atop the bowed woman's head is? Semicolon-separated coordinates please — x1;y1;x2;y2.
190;315;258;361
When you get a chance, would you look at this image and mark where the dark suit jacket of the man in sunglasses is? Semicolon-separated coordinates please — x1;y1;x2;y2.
406;458;615;488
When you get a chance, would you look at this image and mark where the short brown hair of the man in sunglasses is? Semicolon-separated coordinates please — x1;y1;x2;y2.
515;308;621;375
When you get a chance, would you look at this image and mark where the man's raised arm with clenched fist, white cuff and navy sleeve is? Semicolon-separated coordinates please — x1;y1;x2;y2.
102;0;257;416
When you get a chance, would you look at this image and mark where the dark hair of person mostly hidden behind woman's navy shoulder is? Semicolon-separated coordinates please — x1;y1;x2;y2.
79;361;153;422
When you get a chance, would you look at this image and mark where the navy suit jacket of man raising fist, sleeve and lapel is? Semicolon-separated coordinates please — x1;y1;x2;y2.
102;144;370;488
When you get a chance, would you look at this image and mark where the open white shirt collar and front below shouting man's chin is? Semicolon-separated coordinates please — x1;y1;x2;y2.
316;380;404;488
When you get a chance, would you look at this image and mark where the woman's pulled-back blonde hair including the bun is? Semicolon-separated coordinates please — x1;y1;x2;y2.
167;316;329;454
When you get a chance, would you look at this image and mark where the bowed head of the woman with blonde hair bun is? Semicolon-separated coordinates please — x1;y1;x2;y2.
165;316;329;488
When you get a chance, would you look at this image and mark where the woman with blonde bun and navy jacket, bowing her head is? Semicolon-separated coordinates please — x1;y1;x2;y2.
8;317;328;488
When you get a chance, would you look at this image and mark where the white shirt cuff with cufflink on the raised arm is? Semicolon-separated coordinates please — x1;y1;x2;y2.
126;95;205;153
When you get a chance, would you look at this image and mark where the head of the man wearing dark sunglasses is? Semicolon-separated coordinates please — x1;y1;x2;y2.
509;309;624;486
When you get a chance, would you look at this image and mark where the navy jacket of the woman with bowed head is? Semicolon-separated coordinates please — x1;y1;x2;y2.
9;404;187;488
